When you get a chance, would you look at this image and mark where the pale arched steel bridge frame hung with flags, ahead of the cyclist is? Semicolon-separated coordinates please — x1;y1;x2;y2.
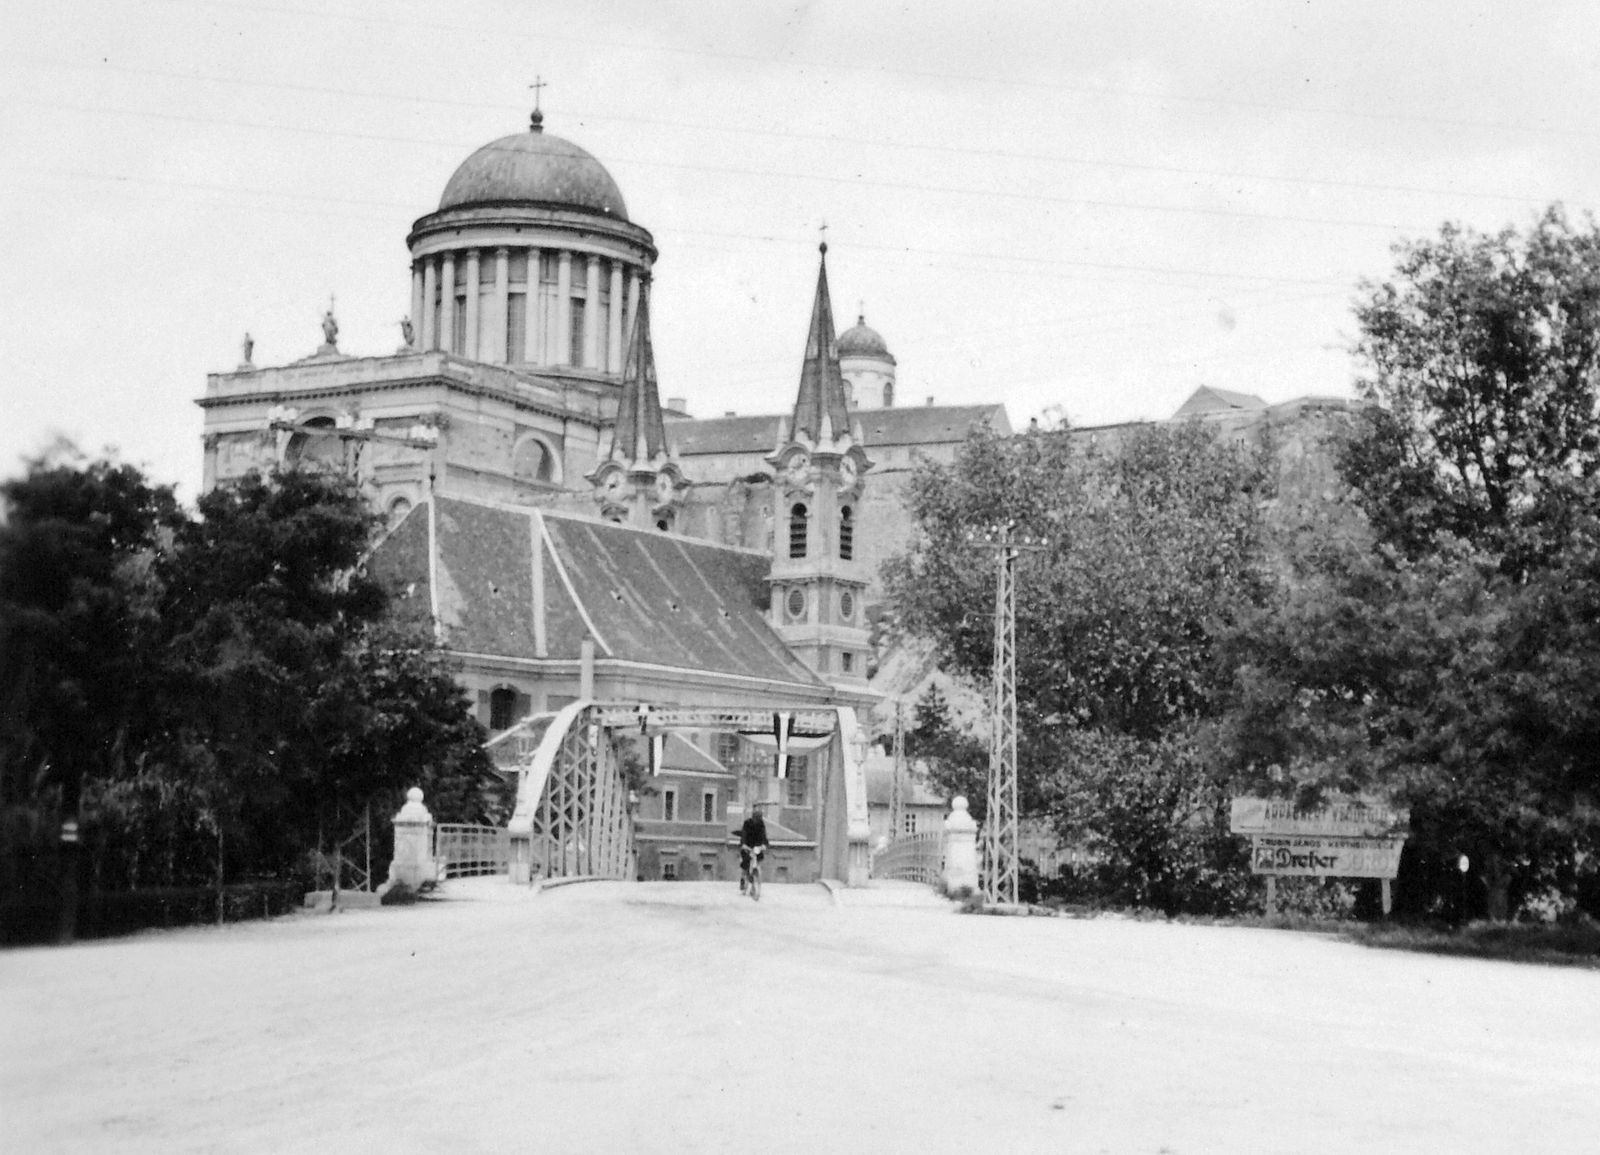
490;701;869;886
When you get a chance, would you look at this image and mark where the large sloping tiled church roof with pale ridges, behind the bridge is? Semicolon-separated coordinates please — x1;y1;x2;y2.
370;498;824;688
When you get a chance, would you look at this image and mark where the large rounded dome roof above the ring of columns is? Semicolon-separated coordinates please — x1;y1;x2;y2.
438;117;627;221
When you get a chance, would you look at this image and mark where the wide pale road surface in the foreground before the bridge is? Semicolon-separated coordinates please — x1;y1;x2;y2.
0;878;1600;1155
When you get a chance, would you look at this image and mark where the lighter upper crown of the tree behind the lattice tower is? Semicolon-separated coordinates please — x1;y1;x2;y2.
885;424;1269;799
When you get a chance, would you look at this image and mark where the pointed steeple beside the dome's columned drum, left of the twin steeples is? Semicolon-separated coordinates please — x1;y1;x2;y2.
589;278;688;530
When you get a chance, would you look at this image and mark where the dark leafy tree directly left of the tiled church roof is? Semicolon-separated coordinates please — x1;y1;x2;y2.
163;470;496;869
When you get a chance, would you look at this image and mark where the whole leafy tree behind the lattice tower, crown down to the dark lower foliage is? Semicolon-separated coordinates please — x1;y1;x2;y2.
885;422;1272;910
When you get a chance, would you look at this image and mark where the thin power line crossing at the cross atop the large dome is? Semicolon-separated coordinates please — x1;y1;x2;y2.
8;56;1589;205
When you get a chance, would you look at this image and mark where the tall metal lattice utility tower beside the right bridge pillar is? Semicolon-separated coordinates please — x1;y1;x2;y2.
968;522;1045;904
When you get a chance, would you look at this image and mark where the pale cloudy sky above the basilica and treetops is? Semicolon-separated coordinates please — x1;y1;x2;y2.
0;0;1600;496
